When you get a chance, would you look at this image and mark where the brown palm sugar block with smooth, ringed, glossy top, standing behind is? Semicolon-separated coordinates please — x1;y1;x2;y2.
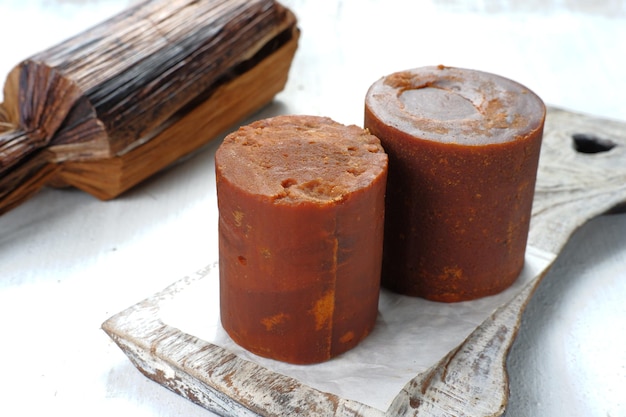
365;66;545;302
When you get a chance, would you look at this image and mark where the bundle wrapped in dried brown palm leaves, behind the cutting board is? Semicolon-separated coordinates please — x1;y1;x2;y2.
0;0;299;214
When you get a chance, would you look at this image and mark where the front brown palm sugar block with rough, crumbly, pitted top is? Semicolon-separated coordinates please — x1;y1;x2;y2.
215;116;387;364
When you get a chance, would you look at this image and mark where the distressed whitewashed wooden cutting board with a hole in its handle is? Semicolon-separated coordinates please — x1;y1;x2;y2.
102;109;626;417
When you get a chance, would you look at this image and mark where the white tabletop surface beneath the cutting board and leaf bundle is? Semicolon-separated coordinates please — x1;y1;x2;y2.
0;0;626;417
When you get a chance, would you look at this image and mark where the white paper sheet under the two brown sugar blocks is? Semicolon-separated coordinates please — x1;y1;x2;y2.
160;247;555;411
